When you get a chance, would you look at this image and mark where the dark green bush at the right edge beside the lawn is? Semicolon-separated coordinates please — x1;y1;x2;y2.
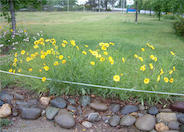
174;17;184;37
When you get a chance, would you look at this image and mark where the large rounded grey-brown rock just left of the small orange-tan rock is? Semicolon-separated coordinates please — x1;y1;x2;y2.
135;114;156;131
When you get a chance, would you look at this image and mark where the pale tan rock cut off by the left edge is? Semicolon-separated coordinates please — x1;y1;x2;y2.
0;104;12;118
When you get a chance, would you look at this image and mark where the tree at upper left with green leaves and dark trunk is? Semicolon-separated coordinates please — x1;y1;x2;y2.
0;0;46;34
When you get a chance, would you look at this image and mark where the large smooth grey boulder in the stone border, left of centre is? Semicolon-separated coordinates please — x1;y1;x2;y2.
54;111;75;129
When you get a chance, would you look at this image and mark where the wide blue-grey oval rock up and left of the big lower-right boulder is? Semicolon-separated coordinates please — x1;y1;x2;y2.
121;105;138;115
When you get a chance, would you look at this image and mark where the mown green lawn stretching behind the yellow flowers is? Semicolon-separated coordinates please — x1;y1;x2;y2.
1;12;184;101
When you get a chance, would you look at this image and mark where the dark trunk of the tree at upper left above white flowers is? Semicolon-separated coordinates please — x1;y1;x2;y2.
9;0;16;35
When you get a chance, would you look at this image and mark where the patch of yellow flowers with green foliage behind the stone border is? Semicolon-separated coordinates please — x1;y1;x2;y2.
3;38;184;100
